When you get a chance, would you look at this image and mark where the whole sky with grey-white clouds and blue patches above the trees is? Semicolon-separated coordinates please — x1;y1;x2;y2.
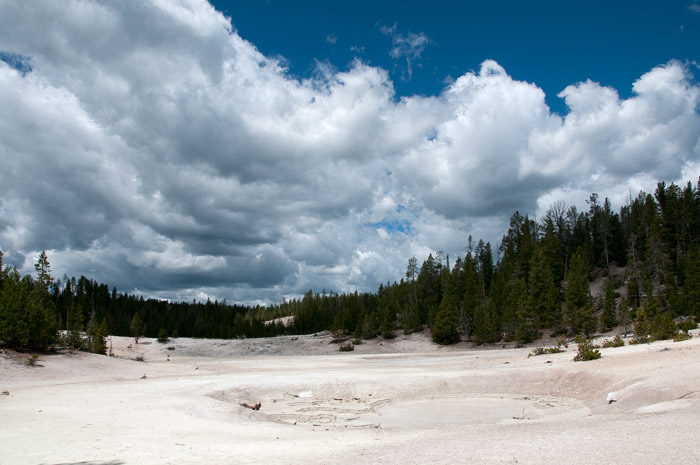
0;0;700;304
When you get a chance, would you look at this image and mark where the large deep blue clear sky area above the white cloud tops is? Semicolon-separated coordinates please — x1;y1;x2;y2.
212;0;700;112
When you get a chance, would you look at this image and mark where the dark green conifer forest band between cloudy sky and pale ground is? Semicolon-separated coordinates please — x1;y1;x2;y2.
0;182;700;352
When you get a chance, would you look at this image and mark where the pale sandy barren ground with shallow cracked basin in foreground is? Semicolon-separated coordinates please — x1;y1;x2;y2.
0;330;700;465
